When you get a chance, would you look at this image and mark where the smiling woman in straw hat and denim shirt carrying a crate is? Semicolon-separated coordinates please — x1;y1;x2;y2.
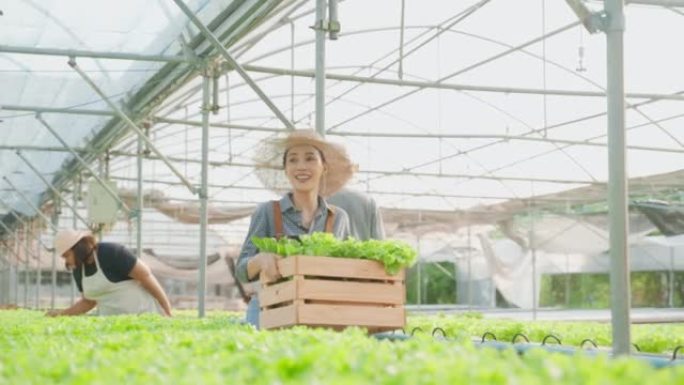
236;130;354;327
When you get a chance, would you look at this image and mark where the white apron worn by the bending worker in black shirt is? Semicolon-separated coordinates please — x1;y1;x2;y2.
81;253;162;315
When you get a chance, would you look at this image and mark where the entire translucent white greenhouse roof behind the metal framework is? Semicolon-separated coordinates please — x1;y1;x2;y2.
0;0;684;228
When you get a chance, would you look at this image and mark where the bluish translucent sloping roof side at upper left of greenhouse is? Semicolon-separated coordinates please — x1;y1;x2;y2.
0;0;280;214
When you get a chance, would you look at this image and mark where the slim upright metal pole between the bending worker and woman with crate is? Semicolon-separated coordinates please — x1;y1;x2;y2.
197;74;211;318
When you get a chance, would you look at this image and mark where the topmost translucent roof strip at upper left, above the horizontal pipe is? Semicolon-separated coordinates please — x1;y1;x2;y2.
0;0;232;54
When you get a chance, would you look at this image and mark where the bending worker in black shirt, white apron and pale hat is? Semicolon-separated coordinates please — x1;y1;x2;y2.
47;230;171;317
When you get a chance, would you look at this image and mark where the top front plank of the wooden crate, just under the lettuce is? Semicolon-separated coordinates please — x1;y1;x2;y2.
278;255;404;281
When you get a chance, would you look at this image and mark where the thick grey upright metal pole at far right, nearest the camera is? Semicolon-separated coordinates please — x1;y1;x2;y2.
604;0;631;355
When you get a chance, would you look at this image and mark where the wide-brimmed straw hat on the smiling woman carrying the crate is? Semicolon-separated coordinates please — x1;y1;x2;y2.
255;130;356;197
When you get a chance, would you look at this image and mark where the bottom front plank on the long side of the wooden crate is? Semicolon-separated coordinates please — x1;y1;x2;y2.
298;304;406;328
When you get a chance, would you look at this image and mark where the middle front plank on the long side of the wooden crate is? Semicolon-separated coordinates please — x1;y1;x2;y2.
297;279;405;305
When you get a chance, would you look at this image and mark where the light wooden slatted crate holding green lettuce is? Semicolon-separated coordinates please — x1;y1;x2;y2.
259;255;406;333
